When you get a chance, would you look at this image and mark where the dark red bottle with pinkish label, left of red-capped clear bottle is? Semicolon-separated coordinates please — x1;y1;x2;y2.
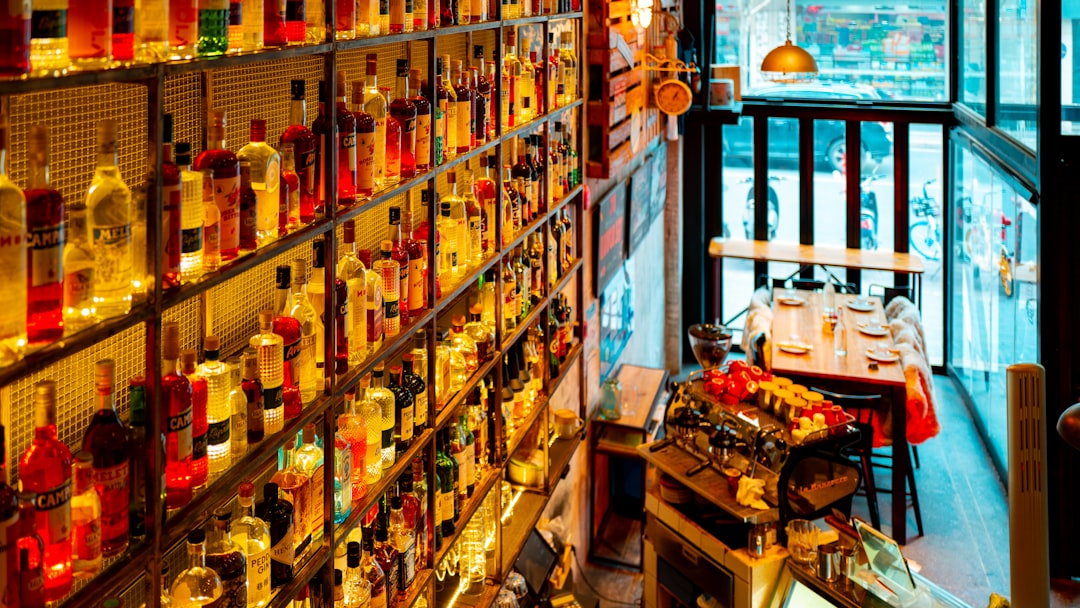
194;110;240;261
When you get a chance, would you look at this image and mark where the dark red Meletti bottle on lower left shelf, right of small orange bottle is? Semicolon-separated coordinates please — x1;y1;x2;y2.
82;359;128;557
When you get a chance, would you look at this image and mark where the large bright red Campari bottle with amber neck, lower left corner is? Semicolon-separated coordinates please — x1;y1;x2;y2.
18;380;71;602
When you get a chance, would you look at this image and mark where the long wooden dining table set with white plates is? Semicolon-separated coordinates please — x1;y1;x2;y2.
771;291;910;544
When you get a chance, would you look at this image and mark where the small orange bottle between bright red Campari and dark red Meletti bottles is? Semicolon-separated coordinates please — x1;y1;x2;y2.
71;451;100;579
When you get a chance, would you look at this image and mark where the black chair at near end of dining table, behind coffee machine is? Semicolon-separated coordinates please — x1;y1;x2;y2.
810;388;922;536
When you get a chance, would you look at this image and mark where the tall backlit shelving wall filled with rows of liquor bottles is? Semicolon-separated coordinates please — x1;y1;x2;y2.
0;0;584;608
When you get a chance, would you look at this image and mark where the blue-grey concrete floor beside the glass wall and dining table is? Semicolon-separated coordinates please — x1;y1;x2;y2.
575;376;1080;608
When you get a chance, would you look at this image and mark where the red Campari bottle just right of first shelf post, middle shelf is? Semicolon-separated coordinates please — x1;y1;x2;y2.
161;322;192;510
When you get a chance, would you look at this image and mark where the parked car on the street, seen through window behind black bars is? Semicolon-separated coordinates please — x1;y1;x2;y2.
724;82;892;171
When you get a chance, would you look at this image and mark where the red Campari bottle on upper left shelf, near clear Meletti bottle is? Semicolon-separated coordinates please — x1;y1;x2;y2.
24;124;64;344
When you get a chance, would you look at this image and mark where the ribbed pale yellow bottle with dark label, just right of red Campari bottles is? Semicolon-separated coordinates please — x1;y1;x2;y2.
192;336;232;475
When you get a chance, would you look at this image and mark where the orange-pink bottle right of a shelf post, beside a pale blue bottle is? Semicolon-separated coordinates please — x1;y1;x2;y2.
334;397;367;511
